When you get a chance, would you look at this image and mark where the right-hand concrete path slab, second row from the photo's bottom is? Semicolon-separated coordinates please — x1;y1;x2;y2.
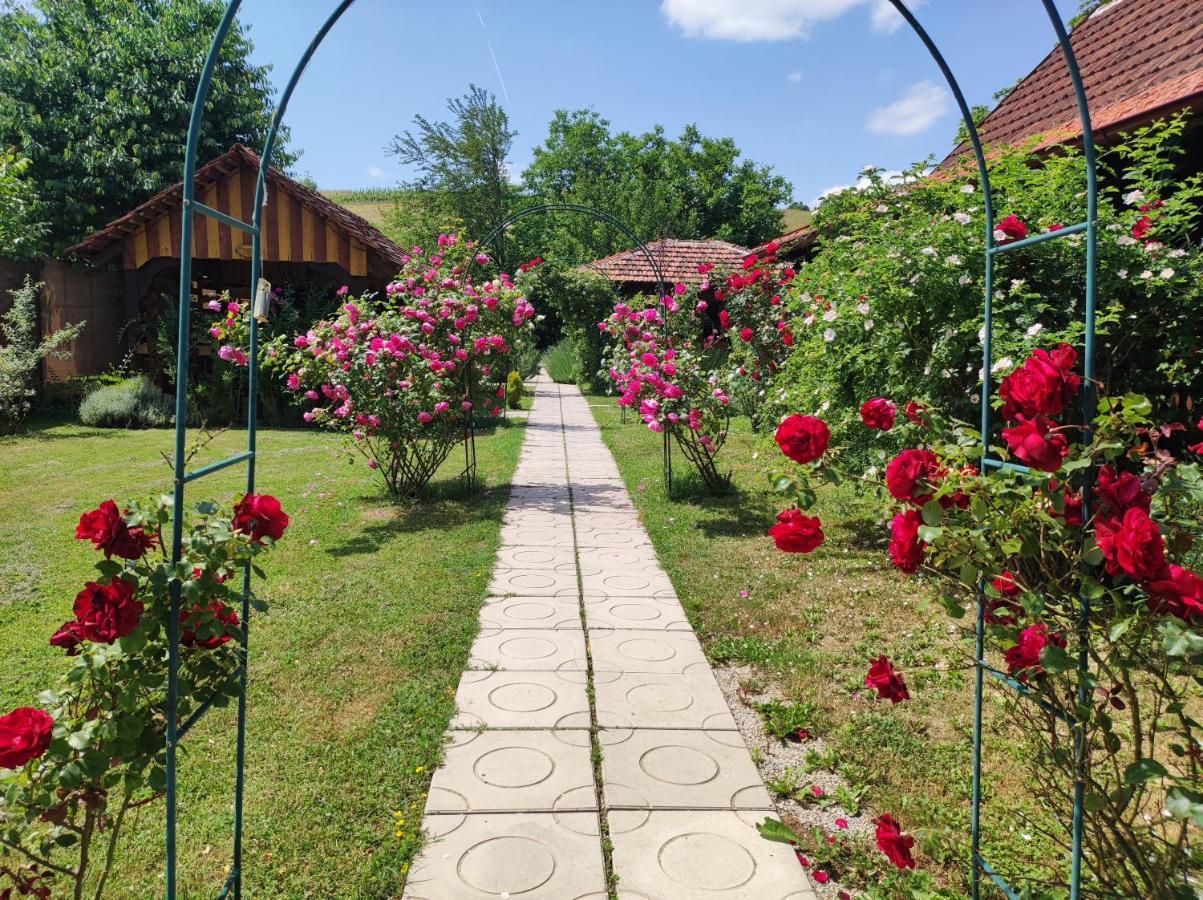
600;728;774;812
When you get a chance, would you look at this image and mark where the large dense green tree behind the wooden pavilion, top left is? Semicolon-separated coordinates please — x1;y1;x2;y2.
0;0;295;251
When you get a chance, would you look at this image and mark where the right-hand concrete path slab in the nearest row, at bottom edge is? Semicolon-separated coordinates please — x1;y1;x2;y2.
610;810;814;900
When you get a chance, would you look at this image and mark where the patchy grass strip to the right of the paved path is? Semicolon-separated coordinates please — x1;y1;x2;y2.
591;397;1067;896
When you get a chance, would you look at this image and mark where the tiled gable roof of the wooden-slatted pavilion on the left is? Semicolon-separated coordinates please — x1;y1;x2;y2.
67;143;405;268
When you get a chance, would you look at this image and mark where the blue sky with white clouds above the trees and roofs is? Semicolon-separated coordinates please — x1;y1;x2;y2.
242;0;1078;202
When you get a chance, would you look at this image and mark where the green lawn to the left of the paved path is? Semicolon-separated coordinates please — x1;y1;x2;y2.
0;420;523;898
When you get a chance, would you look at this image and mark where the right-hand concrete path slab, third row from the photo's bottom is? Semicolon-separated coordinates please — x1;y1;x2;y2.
593;671;735;732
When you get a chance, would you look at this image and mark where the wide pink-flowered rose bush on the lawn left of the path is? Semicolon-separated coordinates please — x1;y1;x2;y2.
277;235;535;499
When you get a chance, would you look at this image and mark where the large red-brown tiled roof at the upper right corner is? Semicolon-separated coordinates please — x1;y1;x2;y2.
941;0;1203;166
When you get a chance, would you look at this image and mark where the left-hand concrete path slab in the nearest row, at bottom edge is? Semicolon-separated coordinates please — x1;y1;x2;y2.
403;812;605;900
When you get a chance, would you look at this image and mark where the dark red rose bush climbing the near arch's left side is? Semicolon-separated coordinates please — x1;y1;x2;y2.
0;495;289;898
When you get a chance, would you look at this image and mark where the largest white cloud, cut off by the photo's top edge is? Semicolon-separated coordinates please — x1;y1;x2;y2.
660;0;928;42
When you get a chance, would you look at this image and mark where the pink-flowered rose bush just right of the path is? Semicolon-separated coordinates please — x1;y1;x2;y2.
598;284;730;491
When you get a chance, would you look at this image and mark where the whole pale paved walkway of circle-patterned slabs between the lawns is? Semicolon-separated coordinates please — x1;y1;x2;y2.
404;378;813;900
